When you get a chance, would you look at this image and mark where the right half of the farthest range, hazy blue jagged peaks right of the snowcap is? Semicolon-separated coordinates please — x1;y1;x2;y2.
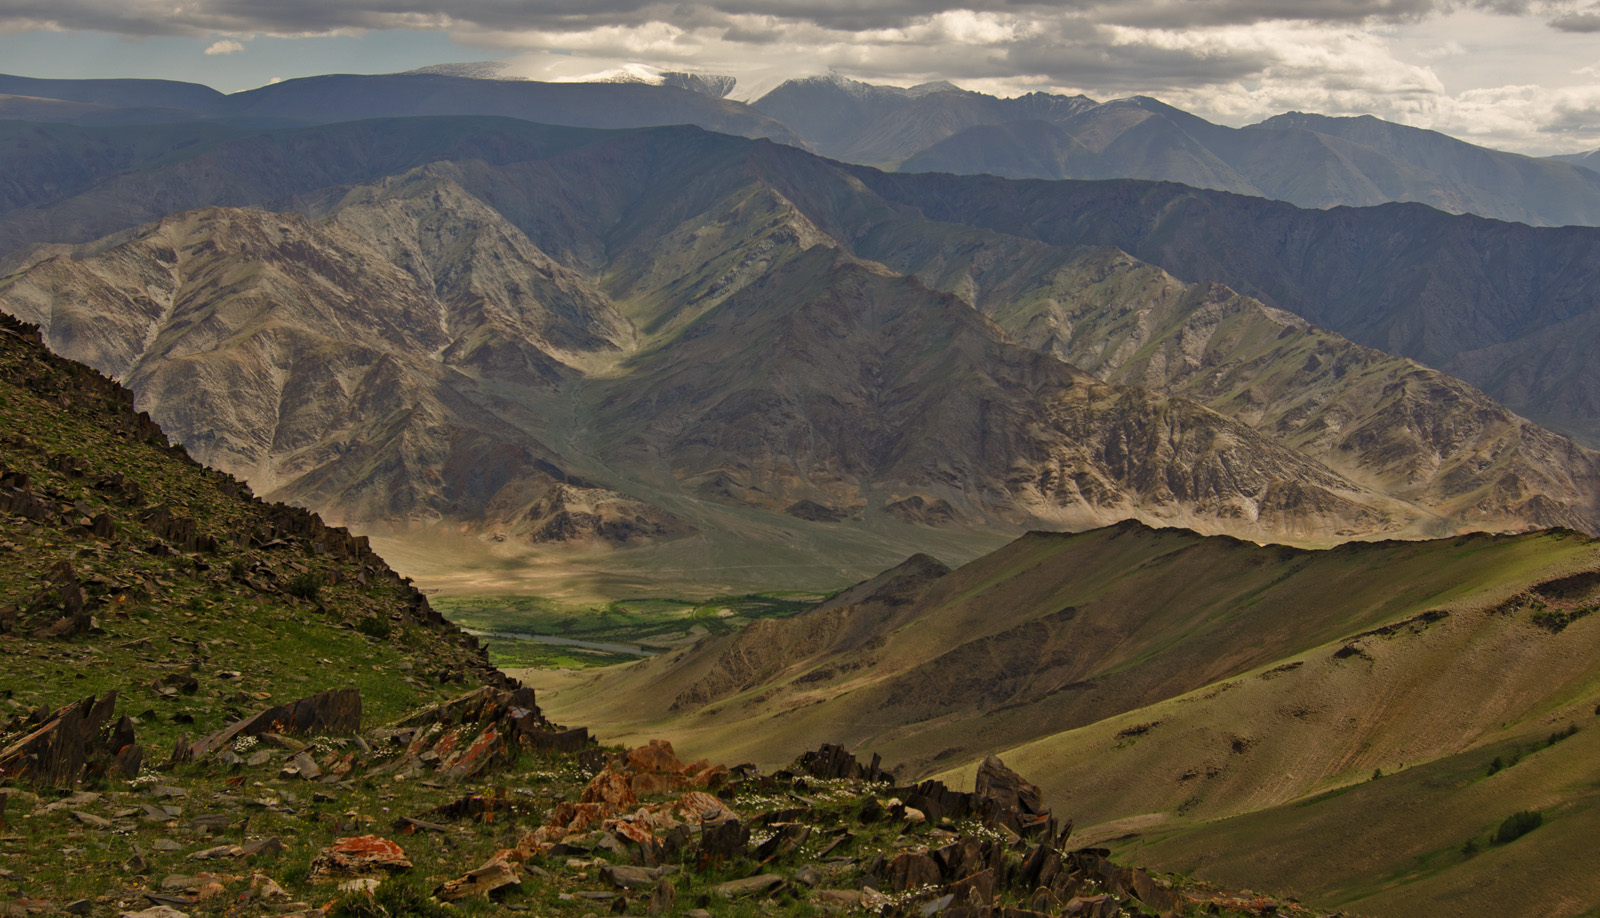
752;75;1600;226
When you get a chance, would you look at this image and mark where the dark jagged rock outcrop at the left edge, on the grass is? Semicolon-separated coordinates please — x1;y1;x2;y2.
0;692;142;787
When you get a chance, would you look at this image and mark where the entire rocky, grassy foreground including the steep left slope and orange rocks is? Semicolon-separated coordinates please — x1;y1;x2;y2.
0;313;1356;918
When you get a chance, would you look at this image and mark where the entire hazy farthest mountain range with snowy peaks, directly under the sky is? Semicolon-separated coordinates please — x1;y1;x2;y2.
0;64;1600;226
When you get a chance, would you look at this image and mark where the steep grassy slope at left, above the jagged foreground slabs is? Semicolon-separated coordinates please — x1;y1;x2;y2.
0;318;505;745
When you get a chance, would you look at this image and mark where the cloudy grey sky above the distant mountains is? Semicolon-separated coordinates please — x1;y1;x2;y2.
0;0;1600;154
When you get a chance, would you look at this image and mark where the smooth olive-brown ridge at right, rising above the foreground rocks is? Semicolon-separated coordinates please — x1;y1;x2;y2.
546;523;1600;915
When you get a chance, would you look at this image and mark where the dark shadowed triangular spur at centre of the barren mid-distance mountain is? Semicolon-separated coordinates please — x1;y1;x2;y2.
600;246;1400;536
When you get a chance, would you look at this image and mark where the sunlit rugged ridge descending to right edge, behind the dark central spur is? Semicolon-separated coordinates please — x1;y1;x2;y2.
885;241;1595;529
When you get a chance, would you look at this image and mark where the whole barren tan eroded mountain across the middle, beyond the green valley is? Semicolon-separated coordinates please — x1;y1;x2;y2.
0;123;1600;544
